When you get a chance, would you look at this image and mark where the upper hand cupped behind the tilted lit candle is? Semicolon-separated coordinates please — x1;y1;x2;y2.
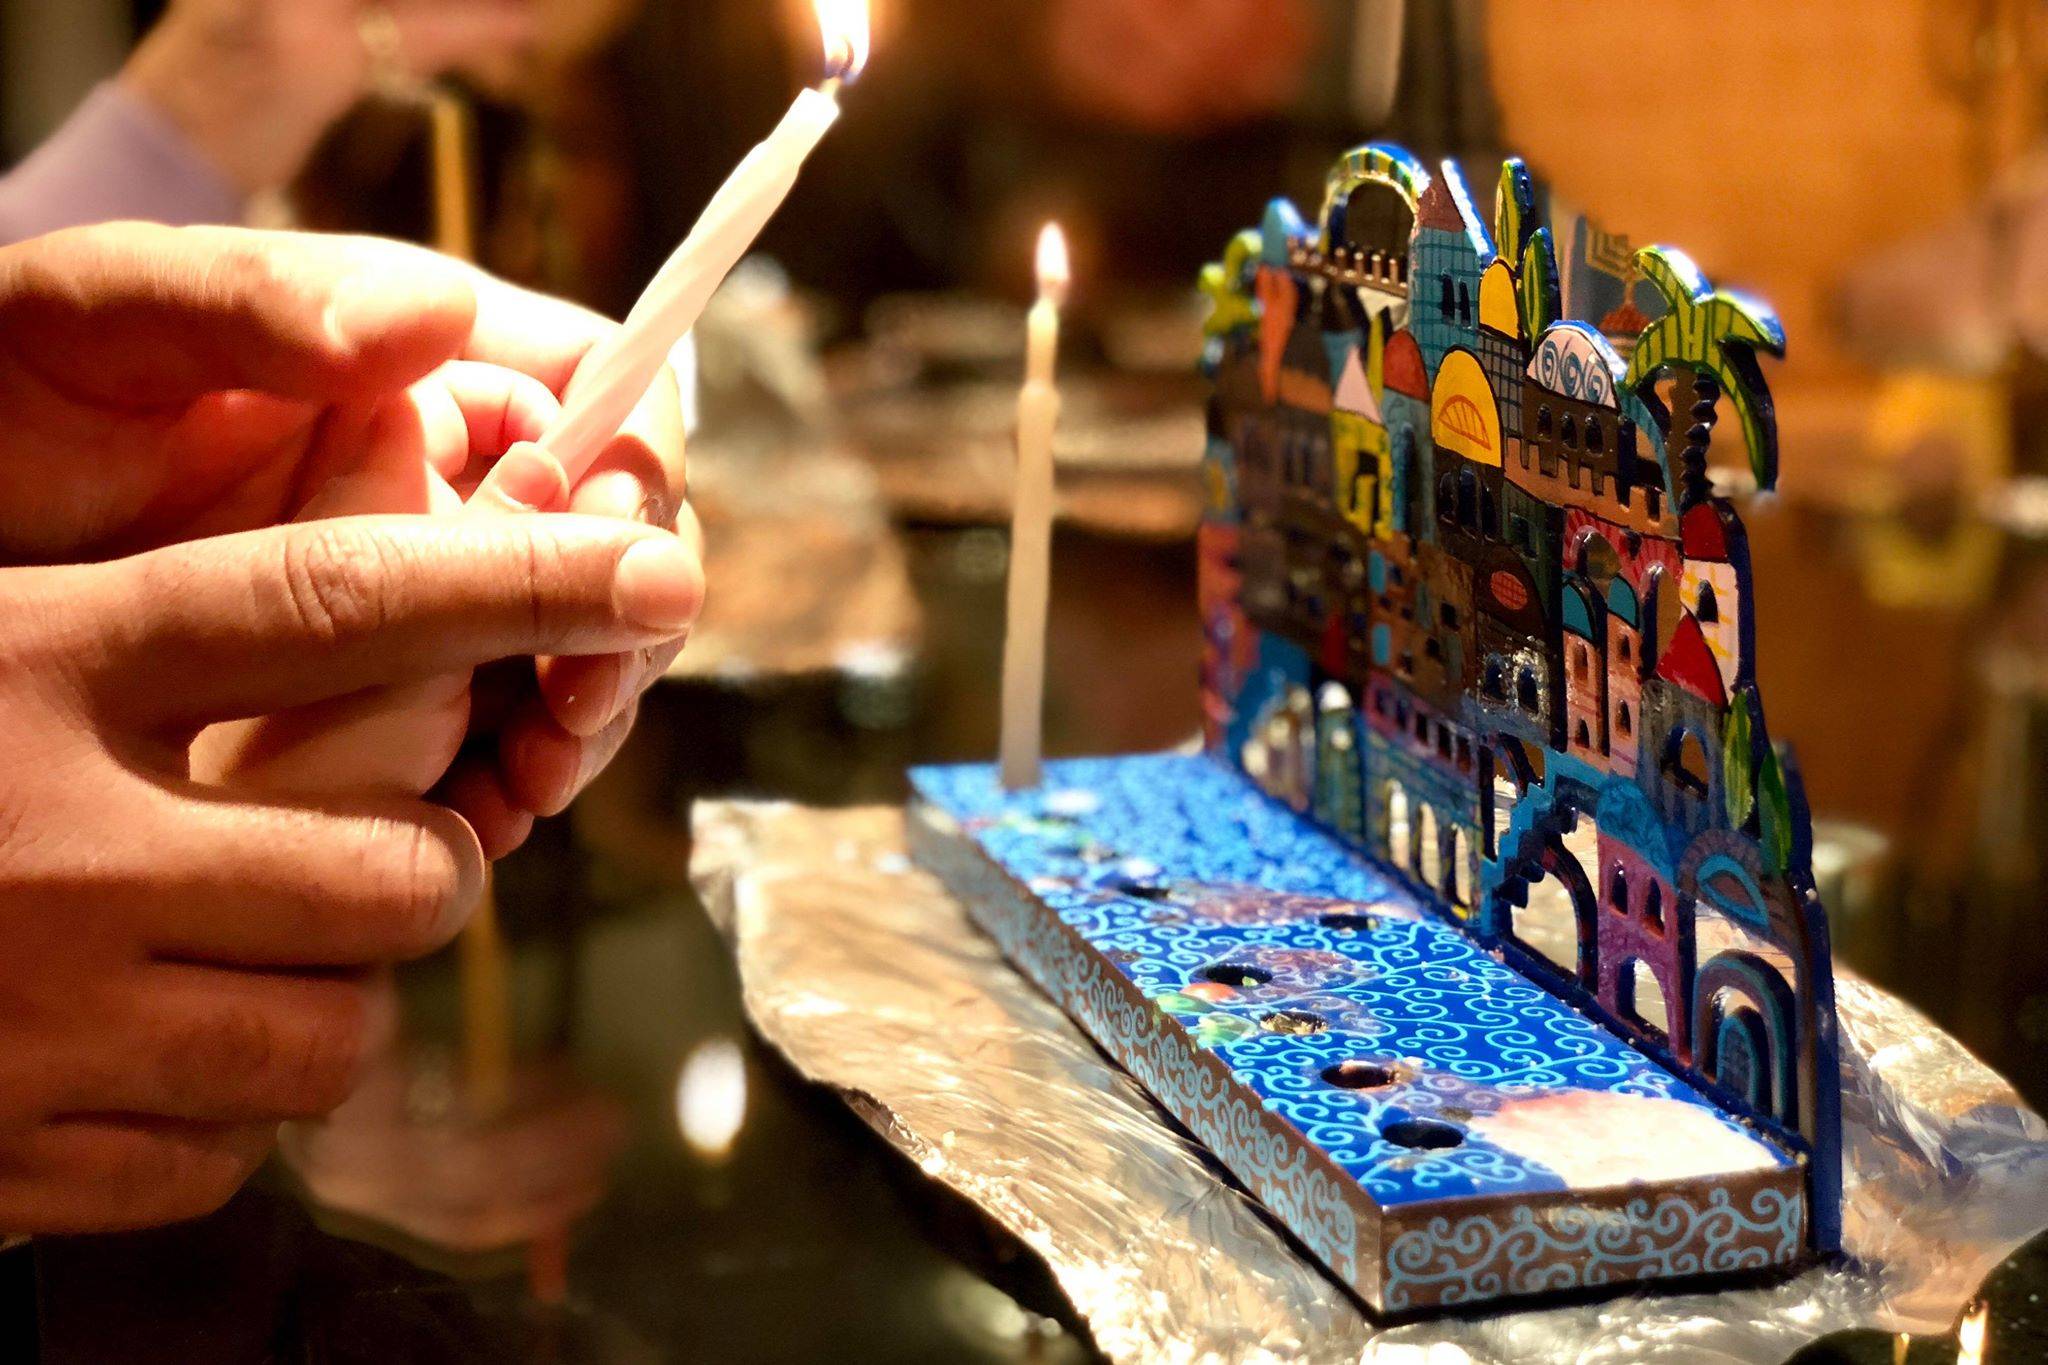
0;223;696;855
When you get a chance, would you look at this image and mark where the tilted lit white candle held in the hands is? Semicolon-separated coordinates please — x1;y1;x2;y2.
520;0;868;483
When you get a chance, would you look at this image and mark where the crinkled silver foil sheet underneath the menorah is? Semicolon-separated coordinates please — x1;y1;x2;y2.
696;804;2048;1365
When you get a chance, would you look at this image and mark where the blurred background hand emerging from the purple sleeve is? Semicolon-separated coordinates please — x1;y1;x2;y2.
121;0;535;192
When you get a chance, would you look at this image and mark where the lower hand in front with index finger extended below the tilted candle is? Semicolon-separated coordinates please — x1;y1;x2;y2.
0;516;700;1232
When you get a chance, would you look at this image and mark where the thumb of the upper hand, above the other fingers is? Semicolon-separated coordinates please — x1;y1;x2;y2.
0;223;477;409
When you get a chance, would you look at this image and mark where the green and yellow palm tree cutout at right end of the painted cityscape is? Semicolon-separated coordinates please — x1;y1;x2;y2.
1622;246;1786;508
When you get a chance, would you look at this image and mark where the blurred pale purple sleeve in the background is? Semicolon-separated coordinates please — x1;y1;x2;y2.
0;80;244;244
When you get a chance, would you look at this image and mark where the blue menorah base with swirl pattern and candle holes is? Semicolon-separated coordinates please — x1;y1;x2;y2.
911;755;1806;1314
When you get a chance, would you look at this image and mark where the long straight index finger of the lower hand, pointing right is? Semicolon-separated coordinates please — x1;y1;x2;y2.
75;514;702;731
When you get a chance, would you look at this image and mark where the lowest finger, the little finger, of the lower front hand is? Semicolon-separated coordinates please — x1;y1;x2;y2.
0;1115;276;1236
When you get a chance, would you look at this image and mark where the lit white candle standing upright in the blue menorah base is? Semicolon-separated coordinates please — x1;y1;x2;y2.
1001;223;1067;792
